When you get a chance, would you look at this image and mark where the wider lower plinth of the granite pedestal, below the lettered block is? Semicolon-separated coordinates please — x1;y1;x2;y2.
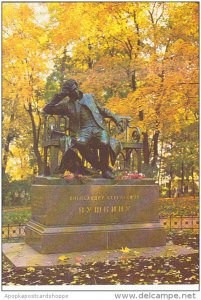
26;221;166;254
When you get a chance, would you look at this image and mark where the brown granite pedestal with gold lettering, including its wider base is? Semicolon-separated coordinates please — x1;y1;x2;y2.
26;177;166;254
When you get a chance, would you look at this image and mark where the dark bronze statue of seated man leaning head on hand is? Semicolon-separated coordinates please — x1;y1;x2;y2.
44;79;142;179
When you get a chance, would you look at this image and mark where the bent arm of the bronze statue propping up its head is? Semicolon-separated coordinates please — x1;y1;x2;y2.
43;92;68;115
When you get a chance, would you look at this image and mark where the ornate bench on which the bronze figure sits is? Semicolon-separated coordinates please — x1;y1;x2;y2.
43;114;143;175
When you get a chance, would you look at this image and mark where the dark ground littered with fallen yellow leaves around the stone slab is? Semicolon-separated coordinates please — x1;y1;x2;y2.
2;234;199;285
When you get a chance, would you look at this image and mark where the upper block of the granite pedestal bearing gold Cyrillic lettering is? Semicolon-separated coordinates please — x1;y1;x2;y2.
32;185;158;226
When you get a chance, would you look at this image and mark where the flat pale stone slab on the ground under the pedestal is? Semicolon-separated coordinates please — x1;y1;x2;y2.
3;243;198;268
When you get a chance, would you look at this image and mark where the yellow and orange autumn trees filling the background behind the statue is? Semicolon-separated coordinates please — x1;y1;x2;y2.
2;2;199;204
